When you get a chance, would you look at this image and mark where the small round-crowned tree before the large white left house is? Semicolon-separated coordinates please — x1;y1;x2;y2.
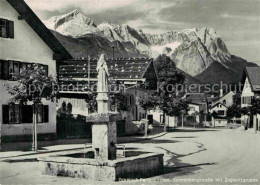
7;64;57;152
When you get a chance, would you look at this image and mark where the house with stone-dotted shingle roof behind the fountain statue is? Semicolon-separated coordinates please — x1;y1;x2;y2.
58;58;158;134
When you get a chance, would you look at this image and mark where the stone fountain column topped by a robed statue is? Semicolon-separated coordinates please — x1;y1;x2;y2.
92;54;116;160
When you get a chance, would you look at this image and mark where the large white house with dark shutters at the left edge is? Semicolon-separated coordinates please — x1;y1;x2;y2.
0;0;71;141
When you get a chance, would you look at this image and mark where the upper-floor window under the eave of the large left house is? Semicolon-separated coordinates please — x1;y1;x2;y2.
0;19;14;38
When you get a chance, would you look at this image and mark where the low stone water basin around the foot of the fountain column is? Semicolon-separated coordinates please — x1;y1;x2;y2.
38;150;163;181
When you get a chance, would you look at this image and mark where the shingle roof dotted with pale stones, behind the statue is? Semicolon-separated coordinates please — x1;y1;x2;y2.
59;58;153;79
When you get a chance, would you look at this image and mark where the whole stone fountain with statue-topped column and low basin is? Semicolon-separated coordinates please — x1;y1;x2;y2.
38;54;163;181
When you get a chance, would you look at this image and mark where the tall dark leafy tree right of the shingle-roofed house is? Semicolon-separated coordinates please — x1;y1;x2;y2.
141;55;188;132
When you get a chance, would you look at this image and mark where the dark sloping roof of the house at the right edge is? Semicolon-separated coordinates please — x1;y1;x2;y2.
245;67;260;91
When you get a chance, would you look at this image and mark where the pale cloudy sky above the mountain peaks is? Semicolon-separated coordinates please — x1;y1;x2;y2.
25;0;260;65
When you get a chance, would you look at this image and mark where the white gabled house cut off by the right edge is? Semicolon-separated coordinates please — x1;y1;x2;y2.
241;67;260;130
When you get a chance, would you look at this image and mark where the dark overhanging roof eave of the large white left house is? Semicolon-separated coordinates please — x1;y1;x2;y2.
7;0;72;59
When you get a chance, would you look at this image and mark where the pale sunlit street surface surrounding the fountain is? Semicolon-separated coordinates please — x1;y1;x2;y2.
0;128;260;184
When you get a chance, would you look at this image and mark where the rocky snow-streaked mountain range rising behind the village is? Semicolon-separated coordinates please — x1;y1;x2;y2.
44;10;256;83
